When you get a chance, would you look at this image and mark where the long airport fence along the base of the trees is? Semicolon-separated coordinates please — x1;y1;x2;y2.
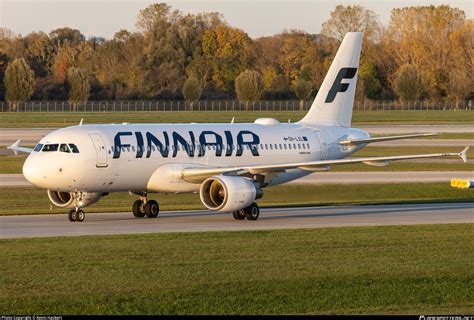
0;100;473;113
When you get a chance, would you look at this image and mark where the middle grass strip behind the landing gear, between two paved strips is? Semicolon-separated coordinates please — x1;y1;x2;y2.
0;183;474;215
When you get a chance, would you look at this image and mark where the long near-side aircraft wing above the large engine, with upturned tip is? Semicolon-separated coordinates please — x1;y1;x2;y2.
182;147;469;183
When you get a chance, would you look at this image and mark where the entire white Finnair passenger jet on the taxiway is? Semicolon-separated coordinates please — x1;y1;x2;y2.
9;32;467;221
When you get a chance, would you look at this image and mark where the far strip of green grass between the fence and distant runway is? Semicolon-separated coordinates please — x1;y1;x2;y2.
0;111;474;128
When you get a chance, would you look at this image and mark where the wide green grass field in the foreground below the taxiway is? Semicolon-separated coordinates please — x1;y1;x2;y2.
0;224;474;315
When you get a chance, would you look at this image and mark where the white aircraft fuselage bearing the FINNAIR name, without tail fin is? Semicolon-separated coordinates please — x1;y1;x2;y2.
23;119;369;193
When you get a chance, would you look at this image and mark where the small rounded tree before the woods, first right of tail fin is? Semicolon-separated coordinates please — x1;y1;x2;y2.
395;64;424;101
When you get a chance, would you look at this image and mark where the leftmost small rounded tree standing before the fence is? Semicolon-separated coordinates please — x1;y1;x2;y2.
4;58;35;110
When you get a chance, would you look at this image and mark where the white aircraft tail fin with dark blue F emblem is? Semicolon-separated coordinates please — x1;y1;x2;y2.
300;32;362;127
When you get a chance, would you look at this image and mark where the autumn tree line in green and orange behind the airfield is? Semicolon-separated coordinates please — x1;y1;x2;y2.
0;3;474;105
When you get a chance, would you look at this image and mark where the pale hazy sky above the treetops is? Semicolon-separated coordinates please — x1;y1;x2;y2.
0;0;474;39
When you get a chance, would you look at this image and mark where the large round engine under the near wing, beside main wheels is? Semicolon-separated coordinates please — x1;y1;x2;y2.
199;175;263;212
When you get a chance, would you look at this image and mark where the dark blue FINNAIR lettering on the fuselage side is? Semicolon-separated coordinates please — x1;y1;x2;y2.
113;130;260;159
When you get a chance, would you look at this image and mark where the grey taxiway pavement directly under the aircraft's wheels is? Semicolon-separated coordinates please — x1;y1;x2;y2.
0;202;474;238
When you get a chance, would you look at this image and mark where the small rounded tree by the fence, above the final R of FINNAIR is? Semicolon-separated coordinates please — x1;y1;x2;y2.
235;70;263;109
